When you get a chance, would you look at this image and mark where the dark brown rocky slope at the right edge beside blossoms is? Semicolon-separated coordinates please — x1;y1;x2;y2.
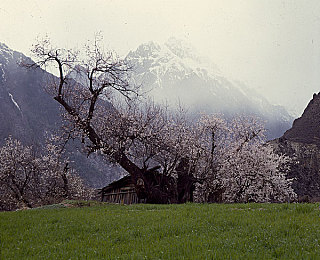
271;93;320;200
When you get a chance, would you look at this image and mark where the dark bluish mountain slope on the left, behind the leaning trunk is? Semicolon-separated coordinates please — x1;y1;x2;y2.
0;43;120;187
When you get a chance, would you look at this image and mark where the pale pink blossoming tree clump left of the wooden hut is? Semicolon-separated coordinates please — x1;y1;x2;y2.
0;137;92;210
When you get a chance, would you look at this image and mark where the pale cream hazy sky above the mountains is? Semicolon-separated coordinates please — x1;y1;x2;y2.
0;0;320;113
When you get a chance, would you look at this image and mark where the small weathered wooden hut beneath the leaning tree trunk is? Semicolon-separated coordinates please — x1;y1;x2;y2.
99;175;144;204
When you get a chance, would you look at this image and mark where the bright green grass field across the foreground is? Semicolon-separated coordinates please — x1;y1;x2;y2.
0;204;320;259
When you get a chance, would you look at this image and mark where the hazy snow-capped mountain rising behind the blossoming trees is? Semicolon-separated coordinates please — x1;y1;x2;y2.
126;38;292;140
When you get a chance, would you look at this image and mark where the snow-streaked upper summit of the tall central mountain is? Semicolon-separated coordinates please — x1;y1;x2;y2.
126;38;220;87
